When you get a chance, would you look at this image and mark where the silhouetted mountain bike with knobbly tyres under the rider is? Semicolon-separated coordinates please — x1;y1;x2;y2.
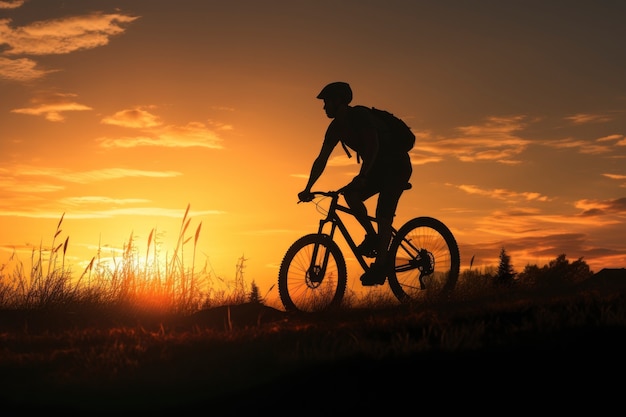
278;183;460;313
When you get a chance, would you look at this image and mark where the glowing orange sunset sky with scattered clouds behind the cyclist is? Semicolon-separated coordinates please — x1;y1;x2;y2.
0;0;626;306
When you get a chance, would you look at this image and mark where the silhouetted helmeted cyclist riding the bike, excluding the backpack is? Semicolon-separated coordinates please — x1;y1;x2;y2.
298;82;413;286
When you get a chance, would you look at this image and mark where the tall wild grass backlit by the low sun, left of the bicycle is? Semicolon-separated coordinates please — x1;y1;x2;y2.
0;205;249;313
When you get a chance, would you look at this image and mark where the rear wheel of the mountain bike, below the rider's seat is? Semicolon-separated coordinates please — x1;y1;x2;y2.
389;217;461;302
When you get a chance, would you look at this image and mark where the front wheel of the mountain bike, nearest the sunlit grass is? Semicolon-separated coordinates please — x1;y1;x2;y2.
278;234;348;313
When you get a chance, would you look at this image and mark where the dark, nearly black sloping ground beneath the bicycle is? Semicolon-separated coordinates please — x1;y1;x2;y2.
0;272;626;416
